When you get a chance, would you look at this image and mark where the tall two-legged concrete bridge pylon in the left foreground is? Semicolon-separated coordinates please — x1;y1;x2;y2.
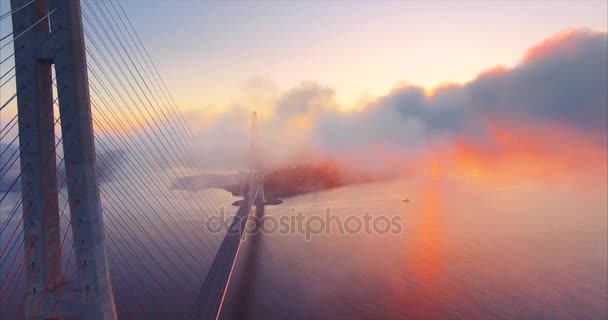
11;0;117;320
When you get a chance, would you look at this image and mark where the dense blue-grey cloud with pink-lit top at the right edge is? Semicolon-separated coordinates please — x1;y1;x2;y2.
465;30;608;144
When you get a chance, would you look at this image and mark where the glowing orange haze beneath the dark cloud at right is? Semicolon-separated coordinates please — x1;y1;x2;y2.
427;122;608;183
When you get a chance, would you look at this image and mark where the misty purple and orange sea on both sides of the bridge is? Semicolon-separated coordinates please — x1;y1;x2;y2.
2;169;608;319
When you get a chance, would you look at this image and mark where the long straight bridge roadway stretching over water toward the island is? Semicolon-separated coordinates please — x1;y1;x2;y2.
187;178;259;320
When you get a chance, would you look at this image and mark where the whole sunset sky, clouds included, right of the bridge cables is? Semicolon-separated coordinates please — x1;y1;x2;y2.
0;0;608;183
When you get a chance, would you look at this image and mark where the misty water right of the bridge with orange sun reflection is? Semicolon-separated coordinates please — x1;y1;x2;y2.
222;181;608;319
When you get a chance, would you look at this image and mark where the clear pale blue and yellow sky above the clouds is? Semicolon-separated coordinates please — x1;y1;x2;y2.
124;0;608;110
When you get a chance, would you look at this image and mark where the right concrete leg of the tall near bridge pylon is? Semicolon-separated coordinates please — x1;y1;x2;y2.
49;0;117;320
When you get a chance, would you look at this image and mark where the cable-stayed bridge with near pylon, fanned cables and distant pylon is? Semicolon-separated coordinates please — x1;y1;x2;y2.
0;0;266;319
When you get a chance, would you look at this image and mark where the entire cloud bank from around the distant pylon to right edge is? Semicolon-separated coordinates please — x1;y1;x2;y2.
183;30;608;181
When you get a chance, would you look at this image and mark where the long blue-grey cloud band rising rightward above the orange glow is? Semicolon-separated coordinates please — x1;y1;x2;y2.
319;30;608;152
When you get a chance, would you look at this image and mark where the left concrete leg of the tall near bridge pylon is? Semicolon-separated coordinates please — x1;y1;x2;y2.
11;0;63;319
